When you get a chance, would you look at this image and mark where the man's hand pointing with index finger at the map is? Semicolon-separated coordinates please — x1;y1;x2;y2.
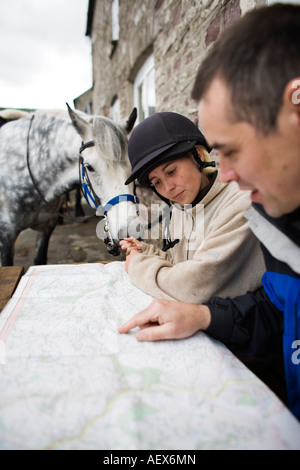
118;299;211;341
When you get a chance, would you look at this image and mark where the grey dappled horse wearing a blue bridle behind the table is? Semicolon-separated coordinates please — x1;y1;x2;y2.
0;106;138;266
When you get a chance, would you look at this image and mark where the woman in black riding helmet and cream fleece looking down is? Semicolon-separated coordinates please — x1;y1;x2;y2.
121;112;264;303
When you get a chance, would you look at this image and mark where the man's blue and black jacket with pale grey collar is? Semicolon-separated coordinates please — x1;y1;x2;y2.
206;205;300;420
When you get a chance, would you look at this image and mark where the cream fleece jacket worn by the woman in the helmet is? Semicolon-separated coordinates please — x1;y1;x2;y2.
128;174;265;303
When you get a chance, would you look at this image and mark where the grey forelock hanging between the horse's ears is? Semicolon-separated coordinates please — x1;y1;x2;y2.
93;117;128;162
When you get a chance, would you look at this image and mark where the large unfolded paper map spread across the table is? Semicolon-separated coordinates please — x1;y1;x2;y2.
0;262;300;450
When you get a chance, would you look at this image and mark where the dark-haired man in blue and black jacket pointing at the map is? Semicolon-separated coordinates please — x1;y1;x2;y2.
119;4;300;420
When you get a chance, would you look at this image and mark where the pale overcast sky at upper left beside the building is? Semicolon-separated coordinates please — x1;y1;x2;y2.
0;0;92;109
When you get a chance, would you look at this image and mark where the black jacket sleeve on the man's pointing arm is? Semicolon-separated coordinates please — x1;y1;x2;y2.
205;287;283;356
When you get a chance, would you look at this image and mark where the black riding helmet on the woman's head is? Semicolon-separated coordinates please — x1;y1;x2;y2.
125;112;215;186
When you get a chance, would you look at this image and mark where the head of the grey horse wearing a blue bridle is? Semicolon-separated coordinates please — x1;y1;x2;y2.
68;106;143;255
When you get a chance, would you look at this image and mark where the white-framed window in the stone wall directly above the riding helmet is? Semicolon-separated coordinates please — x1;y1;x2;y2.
133;55;156;123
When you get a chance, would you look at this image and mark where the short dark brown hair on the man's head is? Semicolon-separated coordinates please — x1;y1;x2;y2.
192;4;300;134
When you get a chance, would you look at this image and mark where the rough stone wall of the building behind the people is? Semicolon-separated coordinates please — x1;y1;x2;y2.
90;0;265;122
